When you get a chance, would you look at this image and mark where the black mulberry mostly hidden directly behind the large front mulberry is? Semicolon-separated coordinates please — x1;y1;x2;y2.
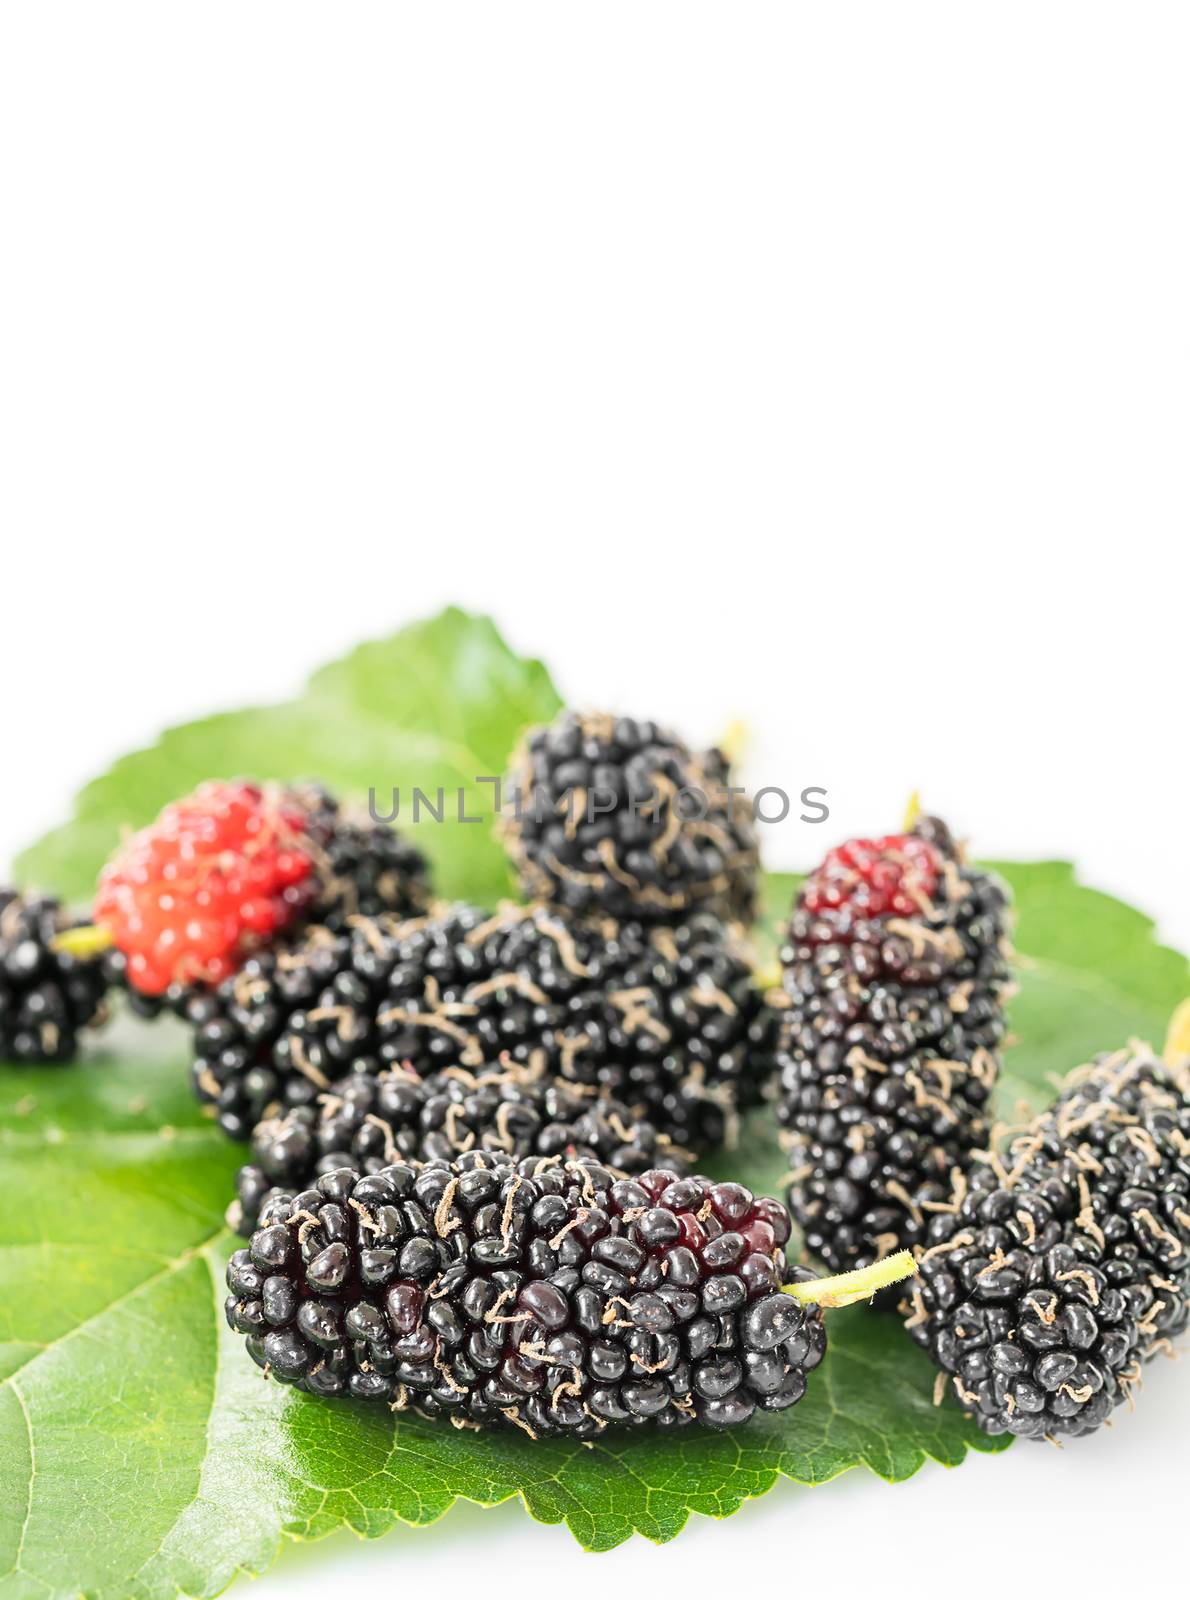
229;1066;688;1237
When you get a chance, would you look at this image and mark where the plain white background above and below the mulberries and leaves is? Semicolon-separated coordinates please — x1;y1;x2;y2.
0;0;1190;1600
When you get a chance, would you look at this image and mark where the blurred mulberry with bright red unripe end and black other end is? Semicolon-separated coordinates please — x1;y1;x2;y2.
94;779;429;1014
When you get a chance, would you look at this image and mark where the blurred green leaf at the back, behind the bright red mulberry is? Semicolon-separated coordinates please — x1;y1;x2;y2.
16;606;560;904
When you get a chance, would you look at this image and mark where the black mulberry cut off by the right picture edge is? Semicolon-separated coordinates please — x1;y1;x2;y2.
905;1045;1190;1440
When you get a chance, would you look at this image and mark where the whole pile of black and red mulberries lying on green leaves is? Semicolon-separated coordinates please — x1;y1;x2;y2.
0;700;1190;1440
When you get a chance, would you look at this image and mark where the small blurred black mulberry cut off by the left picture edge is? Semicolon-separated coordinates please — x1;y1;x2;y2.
0;888;107;1061
